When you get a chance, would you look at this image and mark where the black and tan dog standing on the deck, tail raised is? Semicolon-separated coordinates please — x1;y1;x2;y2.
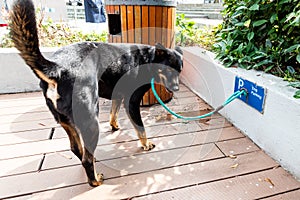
10;0;182;186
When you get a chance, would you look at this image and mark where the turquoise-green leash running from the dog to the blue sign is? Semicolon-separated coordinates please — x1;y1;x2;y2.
151;78;247;120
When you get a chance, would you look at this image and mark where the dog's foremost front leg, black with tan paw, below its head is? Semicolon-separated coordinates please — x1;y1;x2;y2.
124;87;155;151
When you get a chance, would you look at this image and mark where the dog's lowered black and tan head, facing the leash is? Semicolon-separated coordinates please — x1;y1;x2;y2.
154;44;183;92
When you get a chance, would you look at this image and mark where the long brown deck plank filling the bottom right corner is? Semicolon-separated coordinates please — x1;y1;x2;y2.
135;168;300;200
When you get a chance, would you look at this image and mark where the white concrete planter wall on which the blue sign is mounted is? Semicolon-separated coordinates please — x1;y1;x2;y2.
181;47;300;179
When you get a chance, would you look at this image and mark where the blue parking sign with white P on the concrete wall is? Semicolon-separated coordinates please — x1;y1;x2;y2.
234;76;266;113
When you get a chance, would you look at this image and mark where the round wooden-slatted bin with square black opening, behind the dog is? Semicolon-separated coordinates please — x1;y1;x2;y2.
105;0;176;106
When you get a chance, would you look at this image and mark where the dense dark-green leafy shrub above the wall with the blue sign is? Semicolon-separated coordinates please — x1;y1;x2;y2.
214;0;300;97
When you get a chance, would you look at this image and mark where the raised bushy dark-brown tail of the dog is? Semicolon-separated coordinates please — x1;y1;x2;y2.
10;0;55;83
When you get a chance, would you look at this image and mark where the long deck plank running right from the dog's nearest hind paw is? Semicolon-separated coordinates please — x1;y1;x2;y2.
23;153;276;199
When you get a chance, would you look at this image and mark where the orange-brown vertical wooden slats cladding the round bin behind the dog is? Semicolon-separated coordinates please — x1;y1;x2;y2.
106;5;176;105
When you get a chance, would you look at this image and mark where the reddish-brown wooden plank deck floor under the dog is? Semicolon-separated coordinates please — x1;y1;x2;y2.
0;86;300;200
